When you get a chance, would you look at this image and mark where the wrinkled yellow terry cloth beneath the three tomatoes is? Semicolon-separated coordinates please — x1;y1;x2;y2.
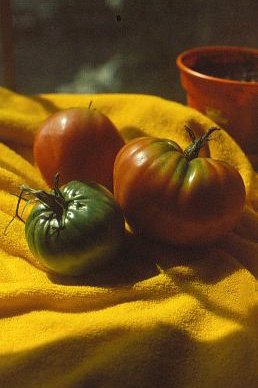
0;88;258;388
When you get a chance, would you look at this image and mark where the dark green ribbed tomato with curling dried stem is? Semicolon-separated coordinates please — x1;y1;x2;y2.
22;176;125;276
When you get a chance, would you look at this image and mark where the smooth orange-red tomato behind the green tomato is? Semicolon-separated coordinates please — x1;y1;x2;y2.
33;107;124;190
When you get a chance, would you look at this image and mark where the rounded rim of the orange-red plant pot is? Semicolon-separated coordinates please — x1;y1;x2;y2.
176;46;258;88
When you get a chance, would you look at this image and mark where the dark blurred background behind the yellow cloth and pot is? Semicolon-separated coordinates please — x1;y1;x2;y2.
0;0;258;103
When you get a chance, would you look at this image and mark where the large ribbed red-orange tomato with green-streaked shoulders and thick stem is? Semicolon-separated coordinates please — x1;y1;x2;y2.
114;128;245;245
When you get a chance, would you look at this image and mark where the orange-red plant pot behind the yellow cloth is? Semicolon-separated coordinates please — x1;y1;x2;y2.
177;46;258;154
